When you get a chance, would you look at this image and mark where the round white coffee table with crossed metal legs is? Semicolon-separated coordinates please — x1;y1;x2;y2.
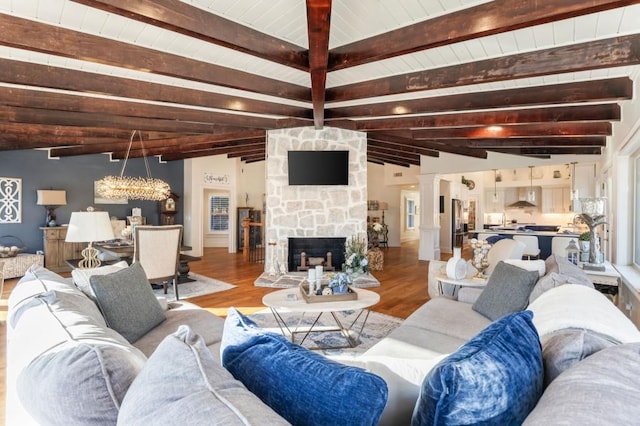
262;287;380;349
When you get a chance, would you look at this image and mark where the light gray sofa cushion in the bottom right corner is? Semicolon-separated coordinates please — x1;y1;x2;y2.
524;343;640;426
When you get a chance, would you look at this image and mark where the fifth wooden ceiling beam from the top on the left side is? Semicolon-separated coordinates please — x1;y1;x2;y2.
0;105;247;134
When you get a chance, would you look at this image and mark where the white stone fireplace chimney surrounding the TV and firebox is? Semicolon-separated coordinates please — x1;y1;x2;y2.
265;127;367;271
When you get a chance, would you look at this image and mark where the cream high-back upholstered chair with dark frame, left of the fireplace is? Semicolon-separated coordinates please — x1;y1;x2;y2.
134;225;182;300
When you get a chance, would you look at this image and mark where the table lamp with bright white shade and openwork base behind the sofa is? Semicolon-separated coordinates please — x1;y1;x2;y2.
65;210;114;269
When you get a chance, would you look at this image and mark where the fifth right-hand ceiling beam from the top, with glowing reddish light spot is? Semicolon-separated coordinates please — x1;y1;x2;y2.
412;121;612;139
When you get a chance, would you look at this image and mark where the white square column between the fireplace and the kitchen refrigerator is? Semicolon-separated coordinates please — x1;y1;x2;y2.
418;173;441;260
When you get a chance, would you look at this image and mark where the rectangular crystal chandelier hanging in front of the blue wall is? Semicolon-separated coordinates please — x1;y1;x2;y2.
96;130;171;201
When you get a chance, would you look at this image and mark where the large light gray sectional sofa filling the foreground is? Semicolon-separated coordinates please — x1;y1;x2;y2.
7;257;640;426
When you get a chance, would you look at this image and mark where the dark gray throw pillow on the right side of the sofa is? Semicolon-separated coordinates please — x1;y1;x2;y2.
472;261;539;321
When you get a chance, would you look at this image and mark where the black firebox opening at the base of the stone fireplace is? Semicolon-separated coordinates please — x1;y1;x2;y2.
287;237;346;271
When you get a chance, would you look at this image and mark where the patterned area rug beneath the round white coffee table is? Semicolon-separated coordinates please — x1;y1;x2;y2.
249;309;402;357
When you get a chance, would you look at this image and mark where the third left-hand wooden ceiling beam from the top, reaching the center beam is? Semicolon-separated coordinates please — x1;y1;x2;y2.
0;58;312;118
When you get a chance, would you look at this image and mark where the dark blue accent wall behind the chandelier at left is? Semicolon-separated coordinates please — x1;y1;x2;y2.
0;150;184;253
